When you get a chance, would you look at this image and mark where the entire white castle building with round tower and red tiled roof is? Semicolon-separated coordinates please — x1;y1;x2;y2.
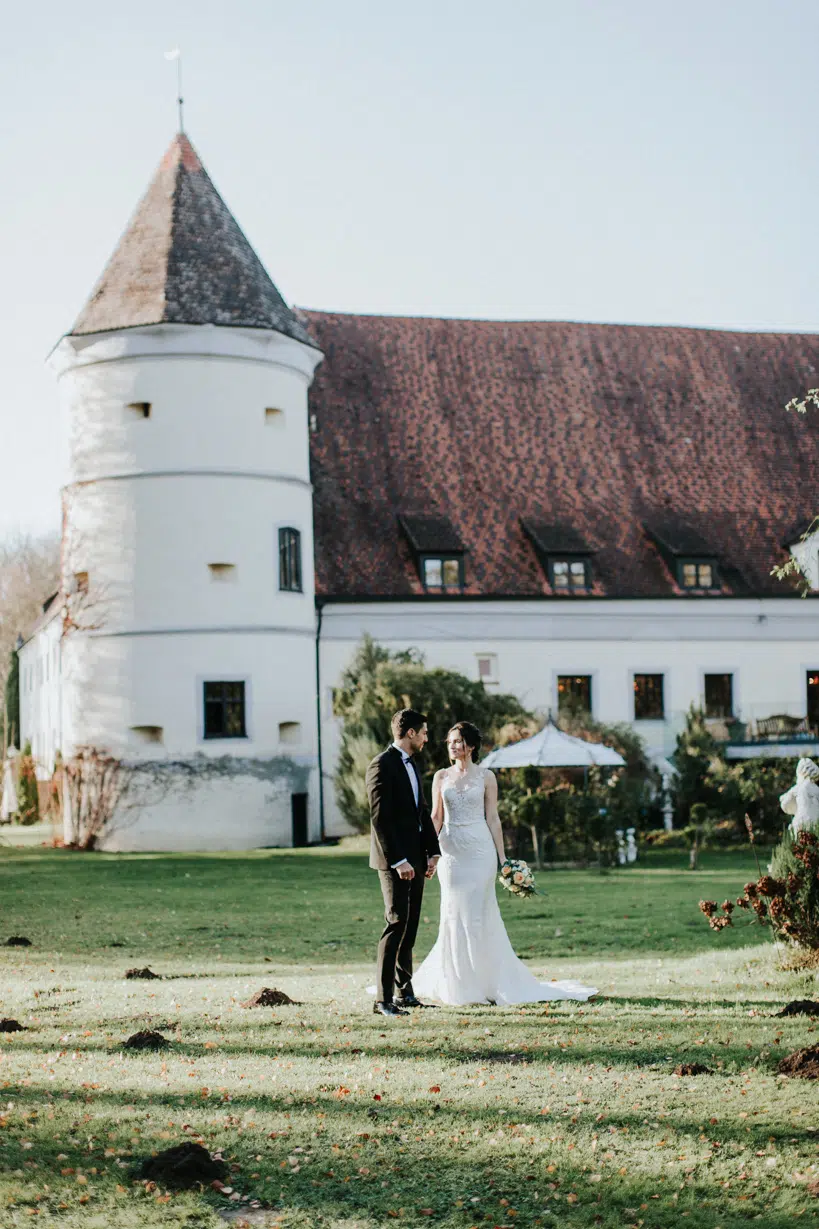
20;134;819;849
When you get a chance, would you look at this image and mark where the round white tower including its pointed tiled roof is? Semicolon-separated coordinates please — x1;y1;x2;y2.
48;134;322;849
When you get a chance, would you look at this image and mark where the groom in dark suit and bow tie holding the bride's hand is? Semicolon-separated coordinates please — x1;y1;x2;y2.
366;708;440;1016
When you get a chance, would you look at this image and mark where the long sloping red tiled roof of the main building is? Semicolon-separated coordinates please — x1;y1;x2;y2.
303;311;819;601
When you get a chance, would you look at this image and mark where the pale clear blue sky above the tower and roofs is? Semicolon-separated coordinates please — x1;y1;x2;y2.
0;0;819;538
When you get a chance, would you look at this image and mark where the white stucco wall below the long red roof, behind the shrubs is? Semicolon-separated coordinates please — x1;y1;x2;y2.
321;599;819;833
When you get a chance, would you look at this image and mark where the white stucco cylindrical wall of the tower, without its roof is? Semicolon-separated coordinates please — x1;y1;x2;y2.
42;326;320;849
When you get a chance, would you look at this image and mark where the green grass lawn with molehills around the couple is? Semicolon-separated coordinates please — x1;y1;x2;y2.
0;846;819;1229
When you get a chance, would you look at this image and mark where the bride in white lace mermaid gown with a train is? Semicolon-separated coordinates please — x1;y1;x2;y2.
413;721;598;1007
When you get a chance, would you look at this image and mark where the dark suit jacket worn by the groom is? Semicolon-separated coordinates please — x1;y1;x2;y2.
366;747;440;870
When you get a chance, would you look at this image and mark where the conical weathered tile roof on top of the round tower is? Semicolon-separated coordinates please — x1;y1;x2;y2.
71;133;316;345
